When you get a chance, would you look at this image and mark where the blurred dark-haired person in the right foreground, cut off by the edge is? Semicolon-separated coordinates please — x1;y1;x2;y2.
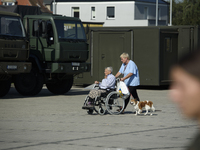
170;50;200;150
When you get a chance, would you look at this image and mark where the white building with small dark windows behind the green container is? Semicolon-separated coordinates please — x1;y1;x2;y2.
53;0;169;26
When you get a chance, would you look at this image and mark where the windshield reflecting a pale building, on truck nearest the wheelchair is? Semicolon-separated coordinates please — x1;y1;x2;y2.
55;20;86;41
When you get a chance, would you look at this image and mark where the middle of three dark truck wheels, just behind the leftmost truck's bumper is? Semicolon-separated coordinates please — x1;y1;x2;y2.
14;69;44;96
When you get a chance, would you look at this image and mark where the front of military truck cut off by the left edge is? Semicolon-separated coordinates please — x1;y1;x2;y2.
0;12;31;97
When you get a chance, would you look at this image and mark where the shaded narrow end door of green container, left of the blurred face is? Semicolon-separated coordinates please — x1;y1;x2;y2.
160;32;178;85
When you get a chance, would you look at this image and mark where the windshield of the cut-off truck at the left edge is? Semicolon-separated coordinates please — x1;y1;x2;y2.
0;15;25;37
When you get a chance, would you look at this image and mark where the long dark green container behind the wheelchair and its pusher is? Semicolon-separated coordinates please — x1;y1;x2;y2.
74;26;200;86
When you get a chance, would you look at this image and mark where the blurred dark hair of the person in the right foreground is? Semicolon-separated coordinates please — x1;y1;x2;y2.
175;50;200;80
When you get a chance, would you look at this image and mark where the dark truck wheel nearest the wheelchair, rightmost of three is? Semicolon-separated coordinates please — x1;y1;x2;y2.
46;76;73;94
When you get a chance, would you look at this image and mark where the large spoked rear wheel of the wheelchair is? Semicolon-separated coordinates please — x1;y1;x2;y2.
106;91;125;115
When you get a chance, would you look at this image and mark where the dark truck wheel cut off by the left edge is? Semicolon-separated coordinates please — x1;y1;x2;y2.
0;79;11;97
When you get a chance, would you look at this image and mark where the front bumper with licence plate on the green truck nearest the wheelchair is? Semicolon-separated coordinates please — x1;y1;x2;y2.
47;62;91;75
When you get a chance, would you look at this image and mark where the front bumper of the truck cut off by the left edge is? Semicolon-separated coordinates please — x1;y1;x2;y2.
0;62;32;74
